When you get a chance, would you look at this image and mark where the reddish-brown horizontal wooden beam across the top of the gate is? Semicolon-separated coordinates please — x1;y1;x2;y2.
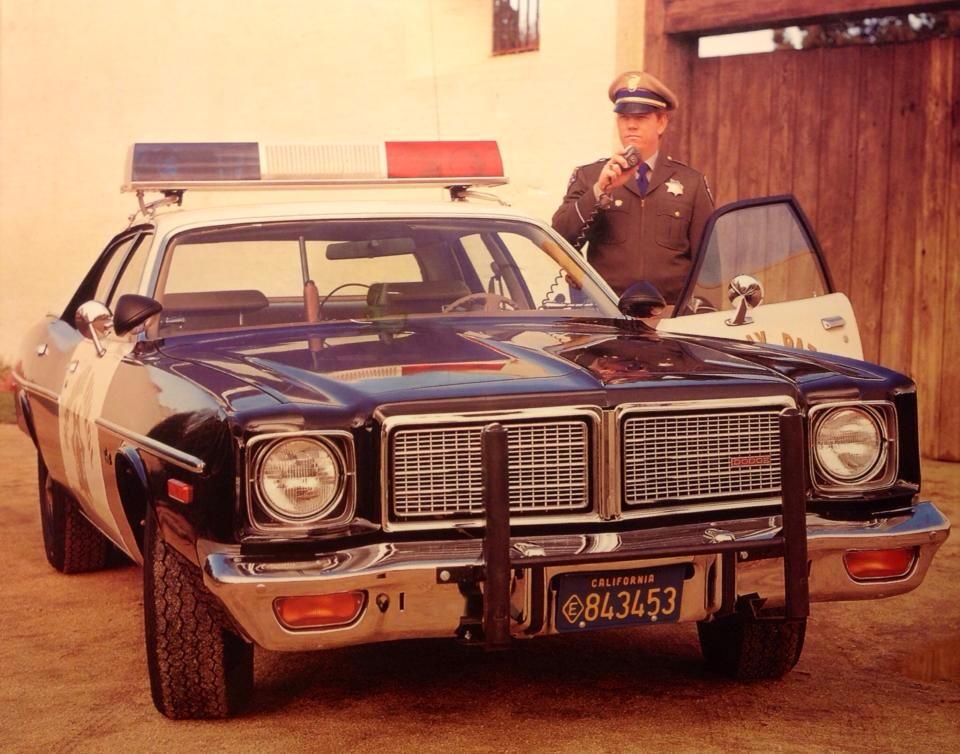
663;0;960;35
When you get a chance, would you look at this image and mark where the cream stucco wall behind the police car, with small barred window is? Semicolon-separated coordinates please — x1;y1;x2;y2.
0;0;643;360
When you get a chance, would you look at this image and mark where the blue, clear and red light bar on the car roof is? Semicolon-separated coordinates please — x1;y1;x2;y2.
123;141;507;191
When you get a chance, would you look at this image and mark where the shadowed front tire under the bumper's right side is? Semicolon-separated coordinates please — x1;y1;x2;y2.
697;613;807;680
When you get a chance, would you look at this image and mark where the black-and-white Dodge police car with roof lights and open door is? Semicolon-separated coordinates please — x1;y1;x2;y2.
15;142;949;718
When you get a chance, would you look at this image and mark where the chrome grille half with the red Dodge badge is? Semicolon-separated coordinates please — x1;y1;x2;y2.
623;409;780;506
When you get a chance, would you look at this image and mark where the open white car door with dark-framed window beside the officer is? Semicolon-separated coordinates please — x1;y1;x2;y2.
657;196;863;359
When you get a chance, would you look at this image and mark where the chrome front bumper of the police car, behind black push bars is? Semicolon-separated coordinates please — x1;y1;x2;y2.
197;502;950;650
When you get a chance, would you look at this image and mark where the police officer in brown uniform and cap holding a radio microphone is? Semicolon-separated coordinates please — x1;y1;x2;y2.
553;71;713;303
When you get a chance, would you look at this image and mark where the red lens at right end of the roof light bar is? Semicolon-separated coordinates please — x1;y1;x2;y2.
386;141;503;178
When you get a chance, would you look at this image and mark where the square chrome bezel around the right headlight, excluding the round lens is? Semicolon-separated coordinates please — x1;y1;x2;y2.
808;400;899;495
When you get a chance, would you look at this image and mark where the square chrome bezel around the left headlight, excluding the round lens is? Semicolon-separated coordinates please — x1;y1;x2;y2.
245;430;356;534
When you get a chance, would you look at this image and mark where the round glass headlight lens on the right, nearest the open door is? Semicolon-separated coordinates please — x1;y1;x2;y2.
814;408;883;483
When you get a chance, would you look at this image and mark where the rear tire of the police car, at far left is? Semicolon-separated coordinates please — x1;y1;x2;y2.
37;455;111;573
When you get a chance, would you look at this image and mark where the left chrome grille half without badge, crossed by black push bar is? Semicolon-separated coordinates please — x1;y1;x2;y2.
390;421;590;520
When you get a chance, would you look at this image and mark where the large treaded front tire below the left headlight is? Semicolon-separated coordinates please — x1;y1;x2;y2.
143;511;253;720
